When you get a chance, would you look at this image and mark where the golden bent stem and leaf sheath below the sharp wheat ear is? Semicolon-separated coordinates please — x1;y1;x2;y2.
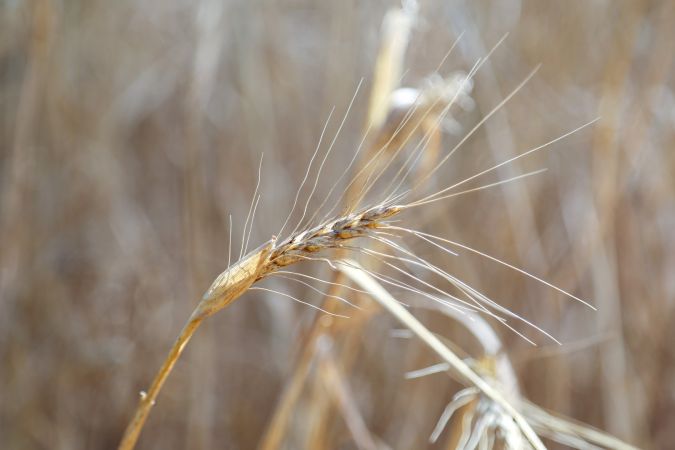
118;240;274;450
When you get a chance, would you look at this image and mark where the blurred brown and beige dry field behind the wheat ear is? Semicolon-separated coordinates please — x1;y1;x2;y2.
0;0;675;449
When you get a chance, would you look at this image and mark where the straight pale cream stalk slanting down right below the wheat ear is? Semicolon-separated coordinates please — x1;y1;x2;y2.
337;261;546;450
